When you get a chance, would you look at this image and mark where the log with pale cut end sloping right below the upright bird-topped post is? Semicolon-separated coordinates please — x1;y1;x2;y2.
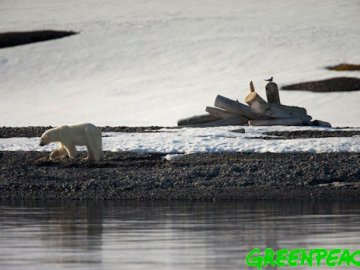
251;100;311;124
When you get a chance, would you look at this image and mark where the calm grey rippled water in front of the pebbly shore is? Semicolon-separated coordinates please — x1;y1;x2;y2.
0;201;360;270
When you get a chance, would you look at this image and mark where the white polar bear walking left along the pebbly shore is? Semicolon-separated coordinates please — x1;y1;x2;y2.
40;123;104;161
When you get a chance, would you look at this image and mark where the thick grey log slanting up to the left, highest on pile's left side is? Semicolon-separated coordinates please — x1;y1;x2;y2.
215;95;262;119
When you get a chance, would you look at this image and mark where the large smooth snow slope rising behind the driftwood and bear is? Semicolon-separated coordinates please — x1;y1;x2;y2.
0;0;360;126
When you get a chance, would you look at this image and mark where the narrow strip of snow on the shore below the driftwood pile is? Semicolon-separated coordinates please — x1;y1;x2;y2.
0;127;360;153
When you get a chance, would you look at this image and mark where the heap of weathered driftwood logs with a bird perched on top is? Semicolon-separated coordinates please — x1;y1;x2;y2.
178;82;331;127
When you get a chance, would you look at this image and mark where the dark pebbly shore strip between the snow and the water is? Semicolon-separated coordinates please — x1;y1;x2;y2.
0;152;360;200
